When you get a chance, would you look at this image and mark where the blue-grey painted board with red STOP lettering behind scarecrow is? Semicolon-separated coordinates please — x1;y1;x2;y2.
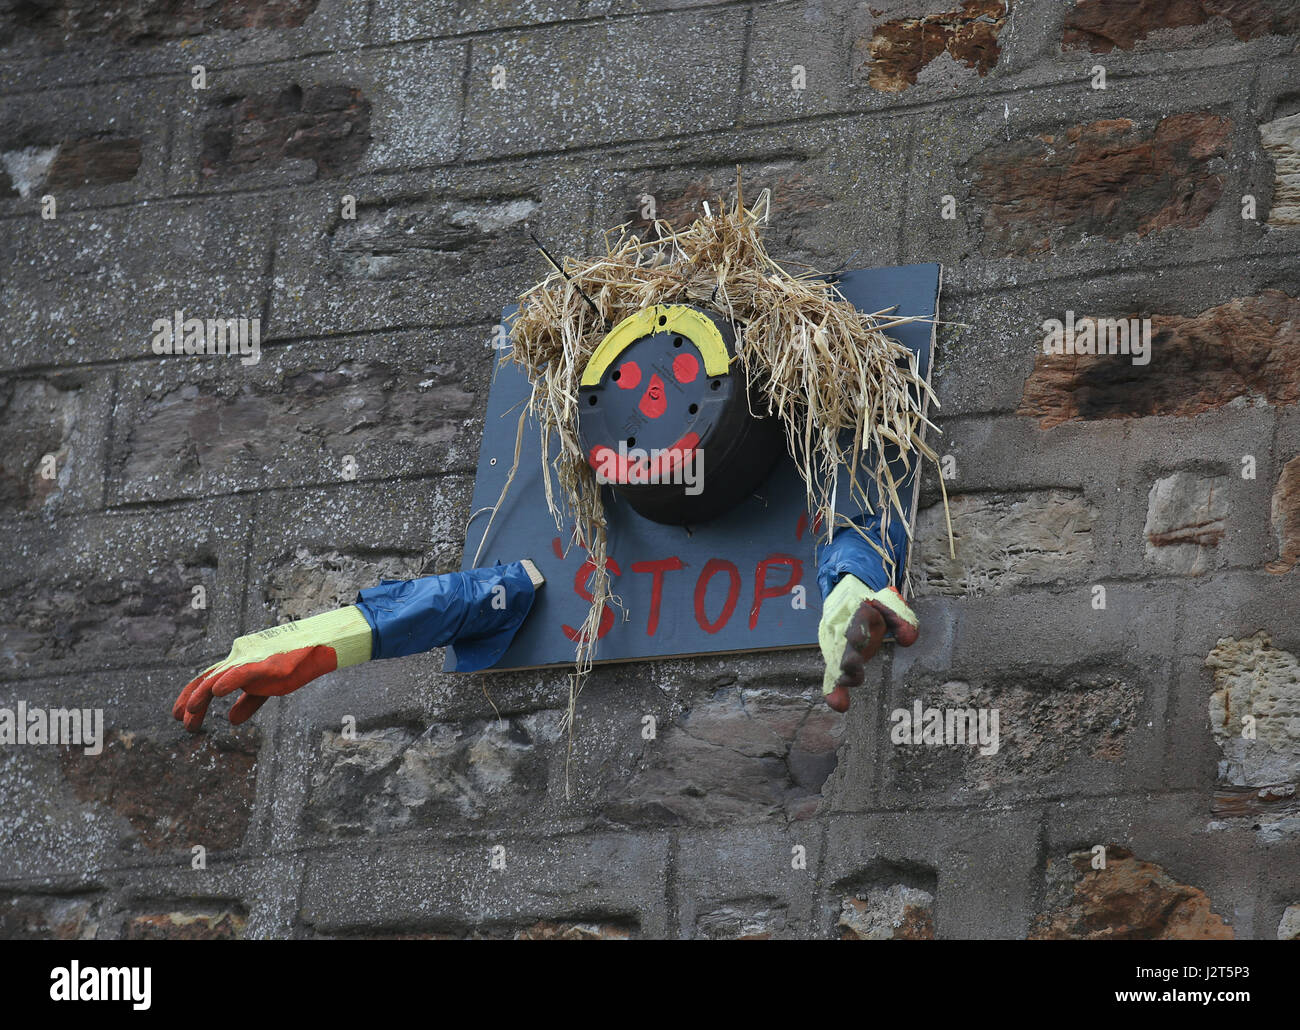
446;264;941;670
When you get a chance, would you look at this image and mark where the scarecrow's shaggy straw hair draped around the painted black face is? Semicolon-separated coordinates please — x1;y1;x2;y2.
502;170;946;775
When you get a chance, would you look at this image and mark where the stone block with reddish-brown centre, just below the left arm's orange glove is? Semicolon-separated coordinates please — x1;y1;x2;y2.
0;660;271;879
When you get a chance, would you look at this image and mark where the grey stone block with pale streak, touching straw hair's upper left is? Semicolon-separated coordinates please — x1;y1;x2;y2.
268;163;589;335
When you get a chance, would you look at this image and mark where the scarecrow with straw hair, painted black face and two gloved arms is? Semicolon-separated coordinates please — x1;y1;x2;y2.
173;182;952;732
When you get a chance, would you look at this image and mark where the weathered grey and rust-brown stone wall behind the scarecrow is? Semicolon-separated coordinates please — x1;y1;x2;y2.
0;0;1300;939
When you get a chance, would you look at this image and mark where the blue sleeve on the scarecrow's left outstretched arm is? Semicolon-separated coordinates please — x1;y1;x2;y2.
356;562;536;672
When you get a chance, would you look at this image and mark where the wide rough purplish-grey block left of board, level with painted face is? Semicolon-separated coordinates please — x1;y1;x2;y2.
111;326;497;501
